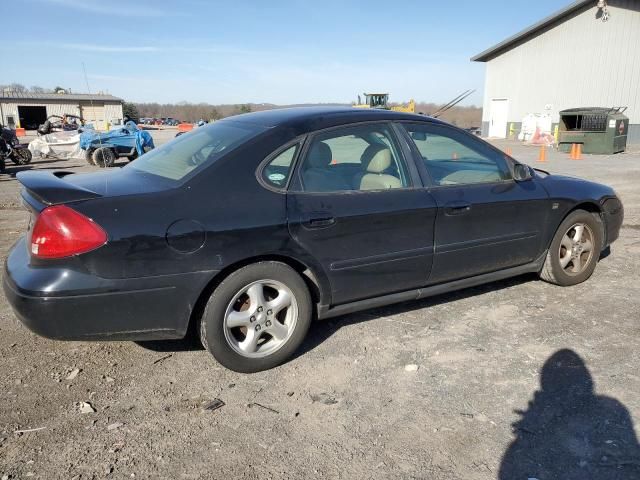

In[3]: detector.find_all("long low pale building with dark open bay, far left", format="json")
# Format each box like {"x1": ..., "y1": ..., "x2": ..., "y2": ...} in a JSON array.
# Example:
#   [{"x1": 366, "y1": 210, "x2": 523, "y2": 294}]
[{"x1": 0, "y1": 92, "x2": 123, "y2": 130}]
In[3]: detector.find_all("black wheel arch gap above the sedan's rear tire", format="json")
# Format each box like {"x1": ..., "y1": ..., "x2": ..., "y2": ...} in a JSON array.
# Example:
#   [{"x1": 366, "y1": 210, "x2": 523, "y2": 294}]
[{"x1": 187, "y1": 255, "x2": 321, "y2": 335}]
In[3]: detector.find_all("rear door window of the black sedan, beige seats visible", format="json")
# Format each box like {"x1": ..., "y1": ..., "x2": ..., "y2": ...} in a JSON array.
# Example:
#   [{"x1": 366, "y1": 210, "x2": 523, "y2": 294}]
[{"x1": 300, "y1": 124, "x2": 411, "y2": 192}]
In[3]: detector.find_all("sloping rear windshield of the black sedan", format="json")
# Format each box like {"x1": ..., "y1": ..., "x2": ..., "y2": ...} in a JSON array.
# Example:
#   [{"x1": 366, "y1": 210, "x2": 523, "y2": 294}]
[{"x1": 125, "y1": 121, "x2": 266, "y2": 180}]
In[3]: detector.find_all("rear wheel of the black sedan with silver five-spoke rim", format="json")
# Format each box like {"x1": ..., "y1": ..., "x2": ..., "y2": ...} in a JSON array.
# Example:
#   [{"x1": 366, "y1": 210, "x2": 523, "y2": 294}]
[{"x1": 200, "y1": 261, "x2": 312, "y2": 373}]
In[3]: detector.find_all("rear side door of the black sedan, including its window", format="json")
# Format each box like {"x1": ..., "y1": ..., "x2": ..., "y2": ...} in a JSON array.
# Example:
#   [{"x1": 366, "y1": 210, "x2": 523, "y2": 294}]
[{"x1": 287, "y1": 123, "x2": 437, "y2": 305}]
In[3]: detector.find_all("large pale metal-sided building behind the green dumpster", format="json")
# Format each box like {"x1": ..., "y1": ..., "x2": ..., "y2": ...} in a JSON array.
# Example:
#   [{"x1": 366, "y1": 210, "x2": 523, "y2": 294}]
[{"x1": 471, "y1": 0, "x2": 640, "y2": 143}]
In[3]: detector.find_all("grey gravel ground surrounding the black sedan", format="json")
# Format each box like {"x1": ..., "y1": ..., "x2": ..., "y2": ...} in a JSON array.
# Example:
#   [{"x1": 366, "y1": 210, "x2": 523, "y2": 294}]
[{"x1": 0, "y1": 132, "x2": 640, "y2": 480}]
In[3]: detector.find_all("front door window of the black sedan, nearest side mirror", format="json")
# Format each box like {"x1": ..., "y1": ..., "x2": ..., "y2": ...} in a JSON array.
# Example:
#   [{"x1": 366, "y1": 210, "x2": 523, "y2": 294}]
[{"x1": 403, "y1": 124, "x2": 512, "y2": 186}]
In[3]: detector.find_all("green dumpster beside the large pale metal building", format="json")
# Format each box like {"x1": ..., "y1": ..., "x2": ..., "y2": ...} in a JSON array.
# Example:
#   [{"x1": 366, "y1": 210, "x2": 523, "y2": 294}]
[{"x1": 558, "y1": 107, "x2": 629, "y2": 155}]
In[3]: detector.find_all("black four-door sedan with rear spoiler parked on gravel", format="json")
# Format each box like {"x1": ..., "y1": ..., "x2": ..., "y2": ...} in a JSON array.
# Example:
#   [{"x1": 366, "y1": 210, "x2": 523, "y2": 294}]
[{"x1": 4, "y1": 108, "x2": 623, "y2": 372}]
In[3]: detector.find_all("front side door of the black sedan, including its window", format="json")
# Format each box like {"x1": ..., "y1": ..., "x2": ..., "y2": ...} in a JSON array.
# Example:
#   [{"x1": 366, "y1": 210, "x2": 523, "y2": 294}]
[{"x1": 403, "y1": 122, "x2": 549, "y2": 283}]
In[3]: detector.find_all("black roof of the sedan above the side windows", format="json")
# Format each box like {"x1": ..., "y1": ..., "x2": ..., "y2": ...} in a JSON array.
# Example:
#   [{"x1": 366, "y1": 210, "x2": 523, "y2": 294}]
[{"x1": 223, "y1": 107, "x2": 441, "y2": 132}]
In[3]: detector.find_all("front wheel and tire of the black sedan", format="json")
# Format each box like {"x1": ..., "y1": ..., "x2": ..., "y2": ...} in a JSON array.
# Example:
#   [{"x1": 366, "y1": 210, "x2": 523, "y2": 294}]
[{"x1": 540, "y1": 210, "x2": 604, "y2": 287}]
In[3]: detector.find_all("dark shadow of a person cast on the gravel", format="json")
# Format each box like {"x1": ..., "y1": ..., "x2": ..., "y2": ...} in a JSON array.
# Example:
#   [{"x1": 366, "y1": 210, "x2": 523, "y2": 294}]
[{"x1": 498, "y1": 349, "x2": 640, "y2": 480}]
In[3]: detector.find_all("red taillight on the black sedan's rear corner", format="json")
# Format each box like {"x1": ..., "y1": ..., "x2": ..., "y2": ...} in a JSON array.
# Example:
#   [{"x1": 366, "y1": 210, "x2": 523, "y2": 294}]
[{"x1": 31, "y1": 205, "x2": 107, "y2": 258}]
